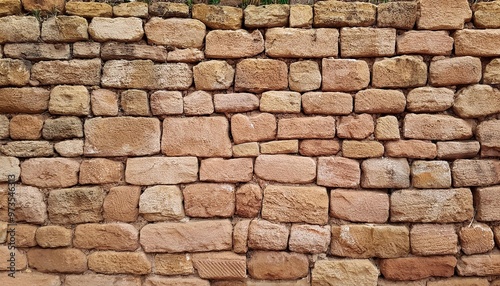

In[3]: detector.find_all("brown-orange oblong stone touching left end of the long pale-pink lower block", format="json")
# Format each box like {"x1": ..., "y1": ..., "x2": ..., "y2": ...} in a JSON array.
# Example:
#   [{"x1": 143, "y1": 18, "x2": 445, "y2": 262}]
[{"x1": 73, "y1": 223, "x2": 139, "y2": 251}]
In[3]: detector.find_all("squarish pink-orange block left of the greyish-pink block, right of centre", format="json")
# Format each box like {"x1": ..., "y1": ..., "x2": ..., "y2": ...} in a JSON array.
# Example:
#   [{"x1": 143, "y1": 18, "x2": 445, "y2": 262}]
[{"x1": 317, "y1": 156, "x2": 361, "y2": 188}]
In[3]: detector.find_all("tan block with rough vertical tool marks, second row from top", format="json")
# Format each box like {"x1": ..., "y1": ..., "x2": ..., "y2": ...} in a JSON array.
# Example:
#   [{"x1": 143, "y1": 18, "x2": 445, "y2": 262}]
[{"x1": 340, "y1": 28, "x2": 396, "y2": 58}]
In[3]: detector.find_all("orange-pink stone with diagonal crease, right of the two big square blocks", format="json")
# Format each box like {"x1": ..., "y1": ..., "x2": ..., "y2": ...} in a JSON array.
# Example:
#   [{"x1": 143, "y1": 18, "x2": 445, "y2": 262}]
[{"x1": 231, "y1": 113, "x2": 277, "y2": 144}]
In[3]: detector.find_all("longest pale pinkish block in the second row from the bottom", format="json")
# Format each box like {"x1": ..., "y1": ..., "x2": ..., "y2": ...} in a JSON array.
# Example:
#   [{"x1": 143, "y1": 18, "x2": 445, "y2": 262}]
[{"x1": 140, "y1": 220, "x2": 233, "y2": 253}]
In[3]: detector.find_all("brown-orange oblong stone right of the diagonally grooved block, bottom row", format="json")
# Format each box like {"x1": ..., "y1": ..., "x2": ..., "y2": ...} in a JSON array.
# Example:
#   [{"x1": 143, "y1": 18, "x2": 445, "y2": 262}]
[{"x1": 248, "y1": 251, "x2": 309, "y2": 280}]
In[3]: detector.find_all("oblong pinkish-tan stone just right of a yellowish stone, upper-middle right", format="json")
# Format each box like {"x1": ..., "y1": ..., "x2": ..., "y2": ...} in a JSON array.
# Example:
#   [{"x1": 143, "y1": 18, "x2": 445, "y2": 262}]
[{"x1": 300, "y1": 91, "x2": 353, "y2": 115}]
